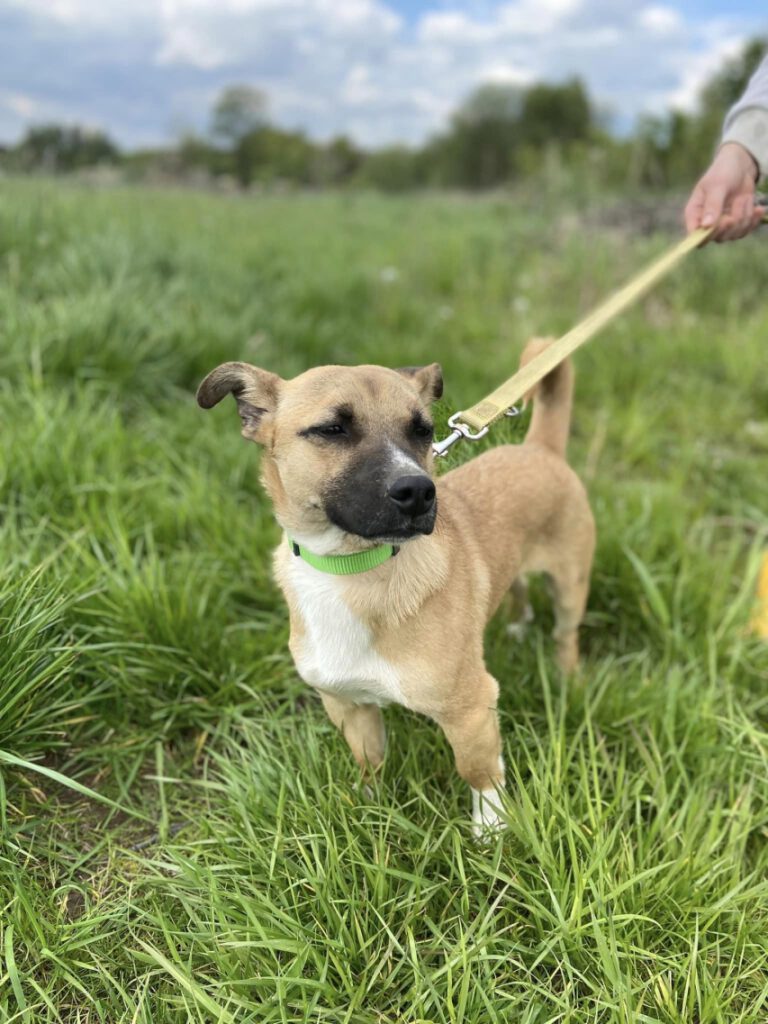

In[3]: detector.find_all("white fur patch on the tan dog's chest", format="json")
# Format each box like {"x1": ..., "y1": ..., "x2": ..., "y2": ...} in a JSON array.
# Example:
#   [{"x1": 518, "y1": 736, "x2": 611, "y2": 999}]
[{"x1": 289, "y1": 558, "x2": 402, "y2": 705}]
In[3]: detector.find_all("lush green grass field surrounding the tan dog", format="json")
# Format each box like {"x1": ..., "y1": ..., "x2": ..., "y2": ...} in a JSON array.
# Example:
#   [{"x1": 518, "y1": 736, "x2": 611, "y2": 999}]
[{"x1": 0, "y1": 181, "x2": 768, "y2": 1024}]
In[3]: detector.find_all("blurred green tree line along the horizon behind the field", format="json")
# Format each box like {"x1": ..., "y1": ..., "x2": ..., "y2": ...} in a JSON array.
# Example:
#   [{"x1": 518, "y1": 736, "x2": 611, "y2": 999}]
[{"x1": 0, "y1": 39, "x2": 768, "y2": 190}]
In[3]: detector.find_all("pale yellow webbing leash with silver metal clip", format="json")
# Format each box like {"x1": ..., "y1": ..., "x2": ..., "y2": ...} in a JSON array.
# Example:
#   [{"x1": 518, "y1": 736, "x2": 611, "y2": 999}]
[{"x1": 432, "y1": 225, "x2": 729, "y2": 456}]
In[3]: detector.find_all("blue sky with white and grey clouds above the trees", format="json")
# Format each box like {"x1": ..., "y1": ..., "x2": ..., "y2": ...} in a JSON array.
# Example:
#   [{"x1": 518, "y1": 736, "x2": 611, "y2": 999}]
[{"x1": 0, "y1": 0, "x2": 768, "y2": 147}]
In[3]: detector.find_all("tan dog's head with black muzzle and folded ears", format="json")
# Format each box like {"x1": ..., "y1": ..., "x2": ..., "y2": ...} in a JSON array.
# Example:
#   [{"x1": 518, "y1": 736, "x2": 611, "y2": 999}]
[{"x1": 198, "y1": 362, "x2": 442, "y2": 553}]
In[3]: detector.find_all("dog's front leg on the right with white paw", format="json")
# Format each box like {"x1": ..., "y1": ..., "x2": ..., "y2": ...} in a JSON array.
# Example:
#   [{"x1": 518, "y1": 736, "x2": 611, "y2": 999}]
[{"x1": 436, "y1": 673, "x2": 504, "y2": 836}]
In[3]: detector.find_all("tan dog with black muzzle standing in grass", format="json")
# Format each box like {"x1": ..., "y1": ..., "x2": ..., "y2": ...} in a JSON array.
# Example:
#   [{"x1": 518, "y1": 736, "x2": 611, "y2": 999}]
[{"x1": 198, "y1": 340, "x2": 595, "y2": 829}]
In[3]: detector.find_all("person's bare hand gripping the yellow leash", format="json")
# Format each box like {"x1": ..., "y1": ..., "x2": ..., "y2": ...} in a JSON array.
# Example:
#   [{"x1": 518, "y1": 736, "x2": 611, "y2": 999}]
[{"x1": 685, "y1": 142, "x2": 766, "y2": 242}]
